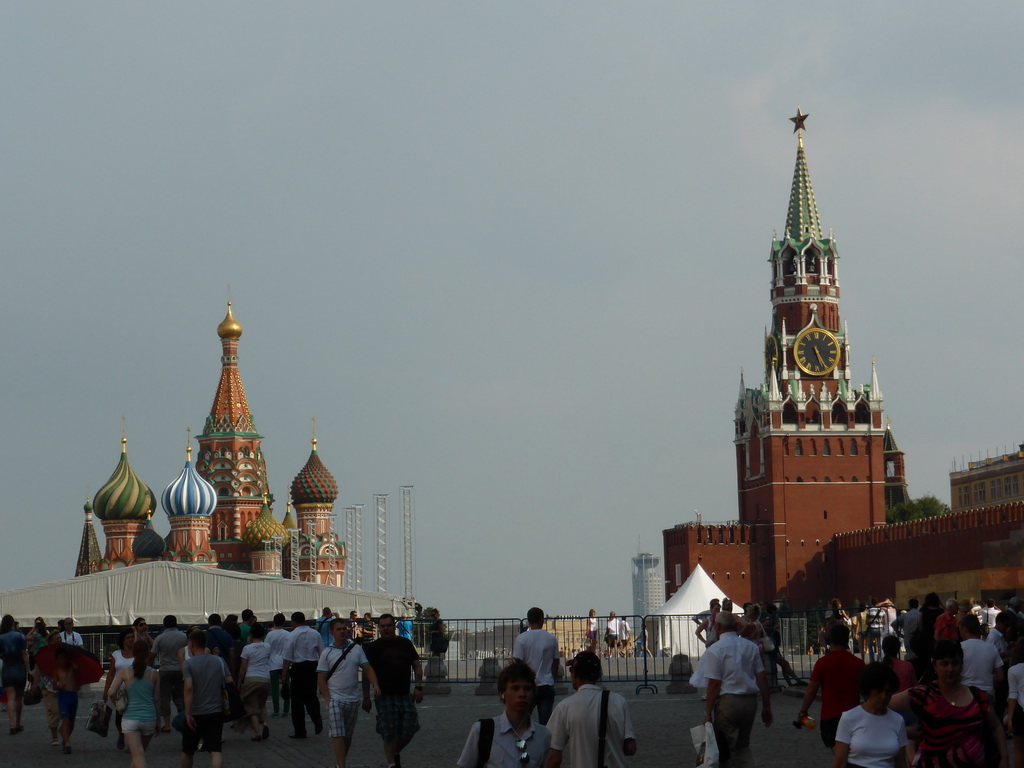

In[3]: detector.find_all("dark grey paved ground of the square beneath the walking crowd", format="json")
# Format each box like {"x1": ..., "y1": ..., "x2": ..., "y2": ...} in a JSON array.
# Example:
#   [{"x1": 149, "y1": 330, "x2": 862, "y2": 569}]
[{"x1": 0, "y1": 683, "x2": 831, "y2": 768}]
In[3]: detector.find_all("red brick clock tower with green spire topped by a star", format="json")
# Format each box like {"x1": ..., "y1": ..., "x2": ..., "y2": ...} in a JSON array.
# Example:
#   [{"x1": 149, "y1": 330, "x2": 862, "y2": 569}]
[{"x1": 734, "y1": 110, "x2": 886, "y2": 607}]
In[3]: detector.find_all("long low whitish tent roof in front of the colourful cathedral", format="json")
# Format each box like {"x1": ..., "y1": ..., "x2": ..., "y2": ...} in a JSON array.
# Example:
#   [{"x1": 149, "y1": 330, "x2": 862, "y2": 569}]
[{"x1": 0, "y1": 562, "x2": 412, "y2": 627}]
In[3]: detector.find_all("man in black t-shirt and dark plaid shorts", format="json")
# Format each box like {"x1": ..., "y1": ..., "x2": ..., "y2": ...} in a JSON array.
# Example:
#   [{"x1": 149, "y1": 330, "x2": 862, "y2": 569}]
[{"x1": 362, "y1": 613, "x2": 423, "y2": 768}]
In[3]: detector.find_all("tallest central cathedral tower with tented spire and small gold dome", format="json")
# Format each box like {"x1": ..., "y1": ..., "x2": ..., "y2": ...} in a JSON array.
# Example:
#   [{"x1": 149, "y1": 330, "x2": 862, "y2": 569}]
[{"x1": 196, "y1": 302, "x2": 272, "y2": 570}]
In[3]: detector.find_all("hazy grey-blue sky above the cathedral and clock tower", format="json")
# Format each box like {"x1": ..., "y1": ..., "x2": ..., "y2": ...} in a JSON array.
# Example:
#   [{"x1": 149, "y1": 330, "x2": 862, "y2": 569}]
[{"x1": 0, "y1": 0, "x2": 1024, "y2": 617}]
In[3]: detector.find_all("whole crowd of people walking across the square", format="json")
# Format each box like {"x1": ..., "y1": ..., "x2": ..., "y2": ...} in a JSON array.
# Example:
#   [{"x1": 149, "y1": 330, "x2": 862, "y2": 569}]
[{"x1": 6, "y1": 593, "x2": 1024, "y2": 768}]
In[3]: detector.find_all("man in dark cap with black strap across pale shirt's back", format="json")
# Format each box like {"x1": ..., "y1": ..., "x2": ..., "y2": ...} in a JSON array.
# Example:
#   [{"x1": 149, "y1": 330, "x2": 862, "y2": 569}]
[{"x1": 548, "y1": 650, "x2": 637, "y2": 768}]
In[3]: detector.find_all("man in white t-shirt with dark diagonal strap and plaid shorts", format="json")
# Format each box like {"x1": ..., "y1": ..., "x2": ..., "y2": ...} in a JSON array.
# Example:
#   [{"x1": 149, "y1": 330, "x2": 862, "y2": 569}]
[{"x1": 316, "y1": 618, "x2": 381, "y2": 768}]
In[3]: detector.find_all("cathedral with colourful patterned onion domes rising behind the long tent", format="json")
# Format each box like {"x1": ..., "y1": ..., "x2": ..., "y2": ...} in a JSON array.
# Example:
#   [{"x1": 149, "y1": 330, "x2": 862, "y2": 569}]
[{"x1": 75, "y1": 302, "x2": 346, "y2": 587}]
